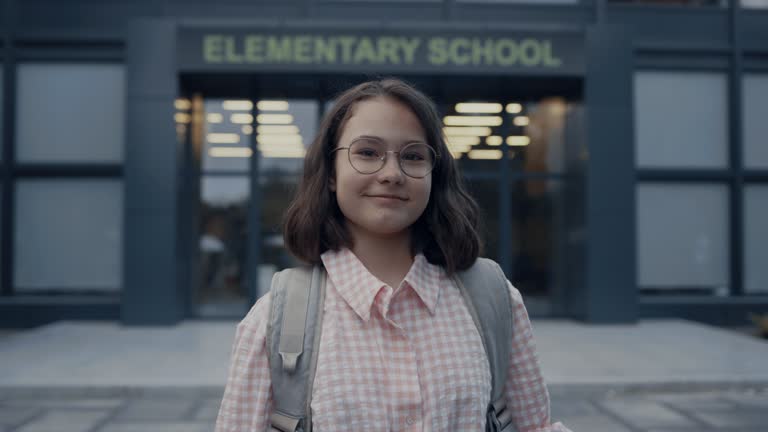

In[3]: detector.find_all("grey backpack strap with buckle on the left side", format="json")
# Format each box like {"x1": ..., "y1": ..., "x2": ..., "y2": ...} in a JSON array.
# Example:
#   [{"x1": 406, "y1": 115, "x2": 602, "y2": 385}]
[{"x1": 267, "y1": 266, "x2": 326, "y2": 432}]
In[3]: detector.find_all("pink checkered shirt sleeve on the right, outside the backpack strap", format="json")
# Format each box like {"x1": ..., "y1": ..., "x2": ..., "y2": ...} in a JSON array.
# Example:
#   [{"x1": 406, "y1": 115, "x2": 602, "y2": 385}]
[{"x1": 505, "y1": 281, "x2": 571, "y2": 432}]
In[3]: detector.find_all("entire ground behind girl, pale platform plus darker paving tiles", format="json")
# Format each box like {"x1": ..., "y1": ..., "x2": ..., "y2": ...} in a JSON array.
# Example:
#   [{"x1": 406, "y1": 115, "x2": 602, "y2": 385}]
[{"x1": 0, "y1": 320, "x2": 768, "y2": 432}]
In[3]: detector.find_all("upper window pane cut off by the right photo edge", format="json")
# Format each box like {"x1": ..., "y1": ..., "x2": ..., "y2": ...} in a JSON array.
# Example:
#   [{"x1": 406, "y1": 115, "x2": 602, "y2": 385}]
[{"x1": 742, "y1": 74, "x2": 768, "y2": 169}]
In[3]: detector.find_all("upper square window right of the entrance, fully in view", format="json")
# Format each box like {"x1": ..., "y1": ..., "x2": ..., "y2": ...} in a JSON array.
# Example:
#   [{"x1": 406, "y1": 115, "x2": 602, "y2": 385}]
[{"x1": 635, "y1": 72, "x2": 728, "y2": 168}]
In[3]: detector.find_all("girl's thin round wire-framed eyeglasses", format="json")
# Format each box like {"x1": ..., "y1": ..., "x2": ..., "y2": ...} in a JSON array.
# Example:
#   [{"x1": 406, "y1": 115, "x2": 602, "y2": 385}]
[{"x1": 331, "y1": 139, "x2": 439, "y2": 178}]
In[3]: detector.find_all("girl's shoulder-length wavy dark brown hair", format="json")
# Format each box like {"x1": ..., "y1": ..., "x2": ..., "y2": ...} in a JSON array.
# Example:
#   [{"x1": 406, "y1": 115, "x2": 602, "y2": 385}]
[{"x1": 283, "y1": 78, "x2": 482, "y2": 274}]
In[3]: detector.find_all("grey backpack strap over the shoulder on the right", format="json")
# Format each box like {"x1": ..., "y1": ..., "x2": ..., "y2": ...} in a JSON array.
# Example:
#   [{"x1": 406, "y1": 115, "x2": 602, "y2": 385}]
[{"x1": 453, "y1": 258, "x2": 515, "y2": 432}]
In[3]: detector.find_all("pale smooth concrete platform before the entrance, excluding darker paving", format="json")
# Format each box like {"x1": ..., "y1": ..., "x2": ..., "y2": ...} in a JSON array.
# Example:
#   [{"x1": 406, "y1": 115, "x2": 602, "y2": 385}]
[{"x1": 0, "y1": 320, "x2": 768, "y2": 394}]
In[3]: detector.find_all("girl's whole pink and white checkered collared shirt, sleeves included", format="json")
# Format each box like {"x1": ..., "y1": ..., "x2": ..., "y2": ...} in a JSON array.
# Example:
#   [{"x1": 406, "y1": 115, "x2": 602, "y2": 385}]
[{"x1": 216, "y1": 249, "x2": 570, "y2": 432}]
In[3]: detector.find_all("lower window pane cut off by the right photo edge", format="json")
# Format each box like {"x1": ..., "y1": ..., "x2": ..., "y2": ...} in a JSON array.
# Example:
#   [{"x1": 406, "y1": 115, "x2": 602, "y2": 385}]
[{"x1": 744, "y1": 185, "x2": 768, "y2": 293}]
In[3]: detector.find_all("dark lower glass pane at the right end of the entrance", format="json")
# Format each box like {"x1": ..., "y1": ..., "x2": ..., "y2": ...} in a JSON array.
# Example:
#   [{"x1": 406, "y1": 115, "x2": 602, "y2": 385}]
[{"x1": 509, "y1": 180, "x2": 565, "y2": 296}]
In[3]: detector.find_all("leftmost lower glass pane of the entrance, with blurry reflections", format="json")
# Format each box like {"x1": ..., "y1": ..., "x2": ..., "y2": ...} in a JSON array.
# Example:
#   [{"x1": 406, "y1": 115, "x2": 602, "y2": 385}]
[{"x1": 197, "y1": 175, "x2": 250, "y2": 316}]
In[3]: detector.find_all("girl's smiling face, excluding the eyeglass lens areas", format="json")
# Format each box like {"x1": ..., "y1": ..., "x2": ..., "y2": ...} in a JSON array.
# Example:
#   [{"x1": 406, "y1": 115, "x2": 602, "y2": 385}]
[{"x1": 330, "y1": 97, "x2": 432, "y2": 238}]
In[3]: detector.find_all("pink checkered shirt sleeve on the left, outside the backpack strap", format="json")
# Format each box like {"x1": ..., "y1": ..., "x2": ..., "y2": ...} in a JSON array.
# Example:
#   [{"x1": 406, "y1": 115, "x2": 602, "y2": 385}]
[{"x1": 215, "y1": 293, "x2": 272, "y2": 432}]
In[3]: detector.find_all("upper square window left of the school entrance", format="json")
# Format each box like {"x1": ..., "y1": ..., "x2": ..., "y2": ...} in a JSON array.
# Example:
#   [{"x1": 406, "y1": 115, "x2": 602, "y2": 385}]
[{"x1": 16, "y1": 63, "x2": 125, "y2": 163}]
